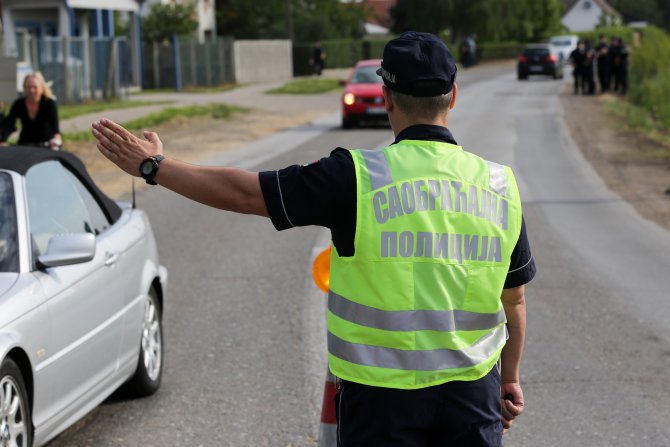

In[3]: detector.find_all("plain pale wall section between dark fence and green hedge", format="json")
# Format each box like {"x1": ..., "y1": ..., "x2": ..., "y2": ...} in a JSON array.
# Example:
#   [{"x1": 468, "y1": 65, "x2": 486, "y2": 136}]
[{"x1": 233, "y1": 40, "x2": 293, "y2": 84}]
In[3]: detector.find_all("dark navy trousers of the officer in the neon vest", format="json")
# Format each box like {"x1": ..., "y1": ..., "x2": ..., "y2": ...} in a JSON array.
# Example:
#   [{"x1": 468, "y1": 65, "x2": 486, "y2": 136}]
[{"x1": 335, "y1": 368, "x2": 502, "y2": 447}]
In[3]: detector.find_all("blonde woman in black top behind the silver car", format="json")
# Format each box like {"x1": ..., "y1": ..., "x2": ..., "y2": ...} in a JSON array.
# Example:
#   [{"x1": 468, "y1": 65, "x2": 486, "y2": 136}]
[{"x1": 0, "y1": 72, "x2": 62, "y2": 150}]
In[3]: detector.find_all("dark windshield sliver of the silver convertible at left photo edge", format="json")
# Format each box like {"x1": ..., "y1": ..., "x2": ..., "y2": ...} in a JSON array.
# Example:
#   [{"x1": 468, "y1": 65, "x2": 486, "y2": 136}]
[{"x1": 0, "y1": 172, "x2": 19, "y2": 272}]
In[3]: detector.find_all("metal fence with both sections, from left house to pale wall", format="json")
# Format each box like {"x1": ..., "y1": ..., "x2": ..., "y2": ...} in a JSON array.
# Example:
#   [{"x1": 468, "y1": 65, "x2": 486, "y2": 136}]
[{"x1": 11, "y1": 34, "x2": 235, "y2": 103}]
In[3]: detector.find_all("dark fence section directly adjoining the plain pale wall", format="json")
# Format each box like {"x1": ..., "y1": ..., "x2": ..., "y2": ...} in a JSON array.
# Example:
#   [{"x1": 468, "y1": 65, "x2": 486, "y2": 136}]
[{"x1": 142, "y1": 38, "x2": 235, "y2": 90}]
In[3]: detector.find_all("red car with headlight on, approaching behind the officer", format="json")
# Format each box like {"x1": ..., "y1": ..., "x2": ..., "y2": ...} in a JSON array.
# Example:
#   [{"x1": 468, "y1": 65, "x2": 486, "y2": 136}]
[{"x1": 342, "y1": 59, "x2": 388, "y2": 129}]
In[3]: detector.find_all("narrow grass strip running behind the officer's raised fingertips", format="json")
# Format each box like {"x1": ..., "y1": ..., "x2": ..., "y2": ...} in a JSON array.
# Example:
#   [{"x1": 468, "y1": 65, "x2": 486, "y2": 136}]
[{"x1": 63, "y1": 104, "x2": 249, "y2": 144}]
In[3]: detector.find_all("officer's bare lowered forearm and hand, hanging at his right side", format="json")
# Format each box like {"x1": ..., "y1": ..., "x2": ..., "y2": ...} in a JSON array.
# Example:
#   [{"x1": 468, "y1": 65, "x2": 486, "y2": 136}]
[{"x1": 500, "y1": 286, "x2": 526, "y2": 431}]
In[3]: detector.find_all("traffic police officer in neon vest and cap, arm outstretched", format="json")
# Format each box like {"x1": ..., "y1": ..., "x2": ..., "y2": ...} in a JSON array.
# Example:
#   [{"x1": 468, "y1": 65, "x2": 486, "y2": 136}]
[{"x1": 93, "y1": 32, "x2": 535, "y2": 447}]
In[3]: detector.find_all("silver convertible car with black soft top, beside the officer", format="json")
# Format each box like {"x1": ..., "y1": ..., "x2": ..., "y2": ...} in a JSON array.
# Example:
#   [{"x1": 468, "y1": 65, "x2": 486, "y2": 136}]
[{"x1": 0, "y1": 147, "x2": 167, "y2": 447}]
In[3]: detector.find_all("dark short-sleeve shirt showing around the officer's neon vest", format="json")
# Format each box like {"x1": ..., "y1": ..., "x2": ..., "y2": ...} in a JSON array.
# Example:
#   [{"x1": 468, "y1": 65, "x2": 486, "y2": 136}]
[{"x1": 259, "y1": 125, "x2": 535, "y2": 288}]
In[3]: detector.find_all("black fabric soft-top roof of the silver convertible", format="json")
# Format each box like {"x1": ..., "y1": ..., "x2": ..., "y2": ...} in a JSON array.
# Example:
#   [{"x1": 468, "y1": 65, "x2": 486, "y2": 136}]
[{"x1": 0, "y1": 146, "x2": 121, "y2": 222}]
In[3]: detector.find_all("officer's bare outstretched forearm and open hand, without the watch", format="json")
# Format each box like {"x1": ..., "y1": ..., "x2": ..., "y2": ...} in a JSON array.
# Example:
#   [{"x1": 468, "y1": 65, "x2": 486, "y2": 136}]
[{"x1": 93, "y1": 119, "x2": 268, "y2": 217}]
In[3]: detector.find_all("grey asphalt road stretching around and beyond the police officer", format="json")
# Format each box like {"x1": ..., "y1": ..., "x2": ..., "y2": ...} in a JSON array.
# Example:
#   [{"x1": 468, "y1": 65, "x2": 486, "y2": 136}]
[{"x1": 50, "y1": 66, "x2": 670, "y2": 447}]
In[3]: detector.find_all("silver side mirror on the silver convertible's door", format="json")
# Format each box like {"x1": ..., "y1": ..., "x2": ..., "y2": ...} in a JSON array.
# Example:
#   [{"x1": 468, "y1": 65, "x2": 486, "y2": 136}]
[{"x1": 37, "y1": 233, "x2": 95, "y2": 267}]
